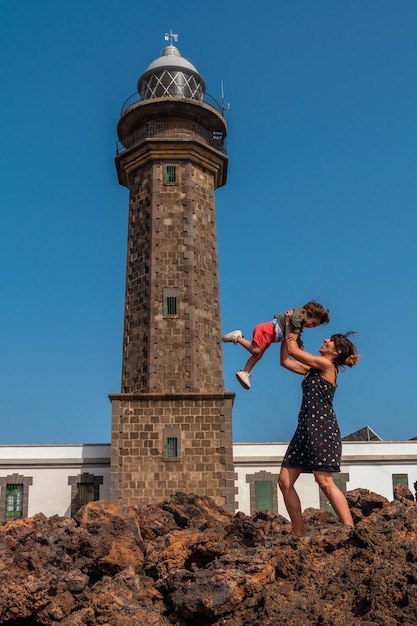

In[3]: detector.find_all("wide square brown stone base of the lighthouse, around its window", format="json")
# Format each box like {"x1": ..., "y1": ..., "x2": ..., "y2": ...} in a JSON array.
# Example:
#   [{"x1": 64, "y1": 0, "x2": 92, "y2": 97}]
[{"x1": 110, "y1": 393, "x2": 235, "y2": 511}]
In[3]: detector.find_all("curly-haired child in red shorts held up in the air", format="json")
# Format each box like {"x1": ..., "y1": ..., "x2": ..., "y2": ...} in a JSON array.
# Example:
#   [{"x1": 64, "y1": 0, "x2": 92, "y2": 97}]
[{"x1": 222, "y1": 300, "x2": 330, "y2": 389}]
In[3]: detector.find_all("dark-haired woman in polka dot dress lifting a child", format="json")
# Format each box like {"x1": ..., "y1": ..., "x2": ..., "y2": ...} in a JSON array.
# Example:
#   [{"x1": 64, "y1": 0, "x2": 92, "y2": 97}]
[{"x1": 279, "y1": 324, "x2": 359, "y2": 537}]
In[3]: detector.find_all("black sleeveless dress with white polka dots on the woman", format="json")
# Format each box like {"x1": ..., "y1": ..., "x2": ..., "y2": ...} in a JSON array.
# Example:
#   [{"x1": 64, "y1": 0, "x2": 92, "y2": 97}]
[{"x1": 282, "y1": 369, "x2": 342, "y2": 472}]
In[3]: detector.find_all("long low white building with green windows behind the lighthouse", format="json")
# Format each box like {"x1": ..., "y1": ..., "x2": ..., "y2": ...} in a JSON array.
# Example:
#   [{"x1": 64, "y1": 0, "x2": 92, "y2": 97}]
[{"x1": 0, "y1": 427, "x2": 417, "y2": 522}]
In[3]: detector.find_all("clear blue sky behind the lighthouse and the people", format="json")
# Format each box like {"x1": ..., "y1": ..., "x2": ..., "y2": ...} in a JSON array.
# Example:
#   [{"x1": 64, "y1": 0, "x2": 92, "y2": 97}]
[{"x1": 0, "y1": 0, "x2": 417, "y2": 443}]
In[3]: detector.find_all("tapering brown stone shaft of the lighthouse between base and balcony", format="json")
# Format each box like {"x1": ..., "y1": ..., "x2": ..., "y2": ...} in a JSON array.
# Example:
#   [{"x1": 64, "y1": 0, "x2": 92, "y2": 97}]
[{"x1": 122, "y1": 160, "x2": 223, "y2": 393}]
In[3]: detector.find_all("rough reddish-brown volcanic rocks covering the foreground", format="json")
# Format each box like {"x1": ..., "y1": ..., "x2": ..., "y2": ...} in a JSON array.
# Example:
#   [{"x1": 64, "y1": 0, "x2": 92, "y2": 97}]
[{"x1": 0, "y1": 488, "x2": 417, "y2": 626}]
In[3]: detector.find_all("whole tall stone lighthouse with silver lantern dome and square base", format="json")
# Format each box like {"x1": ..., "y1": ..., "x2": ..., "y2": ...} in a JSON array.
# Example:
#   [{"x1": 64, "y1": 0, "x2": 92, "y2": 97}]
[{"x1": 110, "y1": 37, "x2": 235, "y2": 510}]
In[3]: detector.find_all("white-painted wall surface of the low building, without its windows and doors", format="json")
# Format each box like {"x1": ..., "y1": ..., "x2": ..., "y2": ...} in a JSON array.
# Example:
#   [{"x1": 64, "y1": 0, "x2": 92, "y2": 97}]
[{"x1": 0, "y1": 440, "x2": 417, "y2": 518}]
